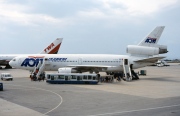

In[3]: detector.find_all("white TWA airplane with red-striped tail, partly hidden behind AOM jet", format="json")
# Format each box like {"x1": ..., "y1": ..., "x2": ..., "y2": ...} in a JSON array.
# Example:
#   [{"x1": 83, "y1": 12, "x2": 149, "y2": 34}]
[{"x1": 0, "y1": 38, "x2": 62, "y2": 68}]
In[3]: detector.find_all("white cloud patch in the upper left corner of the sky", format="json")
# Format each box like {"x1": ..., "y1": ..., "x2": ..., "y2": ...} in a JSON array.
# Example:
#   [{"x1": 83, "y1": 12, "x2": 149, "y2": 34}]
[{"x1": 0, "y1": 1, "x2": 64, "y2": 26}]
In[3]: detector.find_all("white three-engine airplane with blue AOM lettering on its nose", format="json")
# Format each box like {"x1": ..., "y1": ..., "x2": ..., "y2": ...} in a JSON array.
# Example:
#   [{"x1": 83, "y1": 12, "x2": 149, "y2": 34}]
[{"x1": 9, "y1": 26, "x2": 168, "y2": 80}]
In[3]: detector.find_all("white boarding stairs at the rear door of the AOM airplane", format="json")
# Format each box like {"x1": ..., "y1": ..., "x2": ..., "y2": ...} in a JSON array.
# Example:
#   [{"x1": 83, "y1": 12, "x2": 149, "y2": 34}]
[{"x1": 123, "y1": 59, "x2": 132, "y2": 81}]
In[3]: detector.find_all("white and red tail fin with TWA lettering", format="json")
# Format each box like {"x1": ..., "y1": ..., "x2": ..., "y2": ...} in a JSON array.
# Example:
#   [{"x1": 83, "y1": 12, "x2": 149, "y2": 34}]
[{"x1": 40, "y1": 38, "x2": 63, "y2": 54}]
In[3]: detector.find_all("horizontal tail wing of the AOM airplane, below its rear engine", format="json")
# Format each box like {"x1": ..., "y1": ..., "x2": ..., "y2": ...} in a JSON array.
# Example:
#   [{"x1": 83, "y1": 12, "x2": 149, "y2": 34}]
[{"x1": 134, "y1": 56, "x2": 165, "y2": 63}]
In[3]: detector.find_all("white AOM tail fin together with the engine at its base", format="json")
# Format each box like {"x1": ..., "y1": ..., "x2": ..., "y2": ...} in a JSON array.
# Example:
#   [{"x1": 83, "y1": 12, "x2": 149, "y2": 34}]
[{"x1": 127, "y1": 26, "x2": 168, "y2": 56}]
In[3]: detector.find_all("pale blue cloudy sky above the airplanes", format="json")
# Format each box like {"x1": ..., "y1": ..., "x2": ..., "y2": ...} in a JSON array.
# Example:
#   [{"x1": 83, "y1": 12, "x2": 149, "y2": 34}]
[{"x1": 0, "y1": 0, "x2": 180, "y2": 59}]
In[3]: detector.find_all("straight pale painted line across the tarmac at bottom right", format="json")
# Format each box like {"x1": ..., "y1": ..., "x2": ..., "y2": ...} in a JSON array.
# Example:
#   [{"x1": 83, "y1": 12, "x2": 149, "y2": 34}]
[{"x1": 88, "y1": 104, "x2": 180, "y2": 116}]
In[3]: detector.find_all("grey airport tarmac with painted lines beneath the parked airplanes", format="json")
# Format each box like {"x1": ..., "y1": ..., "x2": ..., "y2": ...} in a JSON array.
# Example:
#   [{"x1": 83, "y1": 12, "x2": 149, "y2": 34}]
[{"x1": 0, "y1": 64, "x2": 180, "y2": 116}]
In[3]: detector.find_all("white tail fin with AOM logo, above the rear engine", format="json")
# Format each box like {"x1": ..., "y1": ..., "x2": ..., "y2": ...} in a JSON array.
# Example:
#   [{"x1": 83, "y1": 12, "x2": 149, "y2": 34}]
[{"x1": 138, "y1": 26, "x2": 165, "y2": 47}]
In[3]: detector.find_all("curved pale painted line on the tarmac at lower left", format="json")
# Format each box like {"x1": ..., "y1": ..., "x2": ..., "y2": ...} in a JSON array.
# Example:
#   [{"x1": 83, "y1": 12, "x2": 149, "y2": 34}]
[{"x1": 7, "y1": 84, "x2": 63, "y2": 115}]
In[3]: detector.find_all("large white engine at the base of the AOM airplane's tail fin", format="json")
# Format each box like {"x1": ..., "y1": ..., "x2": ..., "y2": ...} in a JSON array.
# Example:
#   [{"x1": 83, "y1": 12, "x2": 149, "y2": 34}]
[{"x1": 127, "y1": 45, "x2": 168, "y2": 56}]
